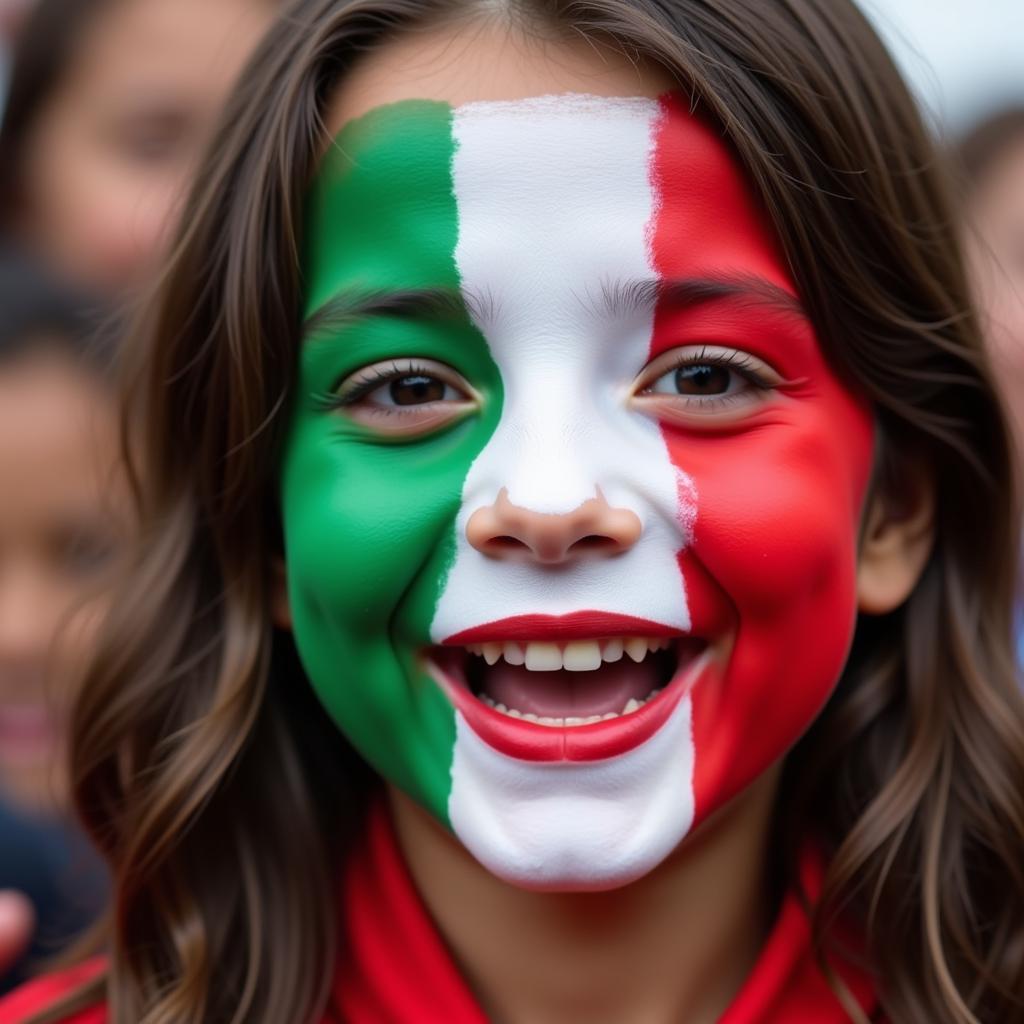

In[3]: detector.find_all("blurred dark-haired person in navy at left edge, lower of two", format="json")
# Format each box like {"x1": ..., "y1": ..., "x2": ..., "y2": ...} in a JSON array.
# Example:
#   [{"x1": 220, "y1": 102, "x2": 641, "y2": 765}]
[{"x1": 0, "y1": 253, "x2": 119, "y2": 991}]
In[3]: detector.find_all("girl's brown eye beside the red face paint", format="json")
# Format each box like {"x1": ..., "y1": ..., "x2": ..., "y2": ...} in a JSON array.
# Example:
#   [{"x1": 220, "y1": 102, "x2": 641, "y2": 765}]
[{"x1": 634, "y1": 345, "x2": 784, "y2": 419}]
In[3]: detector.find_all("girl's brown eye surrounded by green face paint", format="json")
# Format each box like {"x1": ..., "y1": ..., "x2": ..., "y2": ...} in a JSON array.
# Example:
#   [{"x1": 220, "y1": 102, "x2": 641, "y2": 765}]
[{"x1": 324, "y1": 358, "x2": 479, "y2": 436}]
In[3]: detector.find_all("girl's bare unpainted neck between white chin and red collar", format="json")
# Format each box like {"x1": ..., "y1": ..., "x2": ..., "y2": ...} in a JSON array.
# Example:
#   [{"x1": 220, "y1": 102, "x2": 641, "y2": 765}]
[{"x1": 390, "y1": 770, "x2": 778, "y2": 1024}]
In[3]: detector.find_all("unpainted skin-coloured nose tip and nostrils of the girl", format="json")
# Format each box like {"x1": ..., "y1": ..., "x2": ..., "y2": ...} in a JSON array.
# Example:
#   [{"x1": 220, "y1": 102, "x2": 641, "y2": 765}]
[{"x1": 466, "y1": 487, "x2": 643, "y2": 565}]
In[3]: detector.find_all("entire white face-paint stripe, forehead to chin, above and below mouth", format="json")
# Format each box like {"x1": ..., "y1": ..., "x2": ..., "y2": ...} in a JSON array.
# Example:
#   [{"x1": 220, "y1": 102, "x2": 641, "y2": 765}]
[{"x1": 431, "y1": 96, "x2": 696, "y2": 889}]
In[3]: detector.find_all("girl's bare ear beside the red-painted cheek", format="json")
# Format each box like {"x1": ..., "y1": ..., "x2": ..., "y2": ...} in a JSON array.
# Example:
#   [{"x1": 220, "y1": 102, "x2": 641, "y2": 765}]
[{"x1": 857, "y1": 477, "x2": 935, "y2": 615}]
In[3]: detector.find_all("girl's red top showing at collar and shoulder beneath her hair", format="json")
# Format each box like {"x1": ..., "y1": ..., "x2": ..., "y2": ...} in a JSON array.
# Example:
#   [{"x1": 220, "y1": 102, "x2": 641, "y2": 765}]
[{"x1": 0, "y1": 806, "x2": 877, "y2": 1024}]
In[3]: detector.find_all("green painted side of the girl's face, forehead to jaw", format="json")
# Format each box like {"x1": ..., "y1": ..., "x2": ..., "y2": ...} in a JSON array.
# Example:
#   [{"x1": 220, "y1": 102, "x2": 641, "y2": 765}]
[{"x1": 281, "y1": 101, "x2": 502, "y2": 822}]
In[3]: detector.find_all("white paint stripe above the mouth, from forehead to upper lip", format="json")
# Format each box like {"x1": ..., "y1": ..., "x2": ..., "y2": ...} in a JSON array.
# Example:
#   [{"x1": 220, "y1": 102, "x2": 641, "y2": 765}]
[{"x1": 431, "y1": 96, "x2": 695, "y2": 641}]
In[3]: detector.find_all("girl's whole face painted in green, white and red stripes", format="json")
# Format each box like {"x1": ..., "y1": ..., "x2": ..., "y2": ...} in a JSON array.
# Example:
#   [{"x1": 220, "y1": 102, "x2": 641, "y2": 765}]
[{"x1": 282, "y1": 22, "x2": 872, "y2": 889}]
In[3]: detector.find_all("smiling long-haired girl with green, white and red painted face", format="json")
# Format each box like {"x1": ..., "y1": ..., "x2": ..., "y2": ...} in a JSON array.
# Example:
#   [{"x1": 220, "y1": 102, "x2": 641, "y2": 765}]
[{"x1": 0, "y1": 0, "x2": 1024, "y2": 1024}]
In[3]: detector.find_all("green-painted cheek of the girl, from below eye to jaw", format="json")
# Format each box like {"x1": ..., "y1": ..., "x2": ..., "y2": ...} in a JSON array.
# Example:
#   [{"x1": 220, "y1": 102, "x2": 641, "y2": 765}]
[{"x1": 282, "y1": 424, "x2": 479, "y2": 820}]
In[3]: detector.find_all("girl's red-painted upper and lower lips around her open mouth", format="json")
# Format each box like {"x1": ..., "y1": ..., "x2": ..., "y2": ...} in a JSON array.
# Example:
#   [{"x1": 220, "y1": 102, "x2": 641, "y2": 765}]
[{"x1": 425, "y1": 611, "x2": 711, "y2": 763}]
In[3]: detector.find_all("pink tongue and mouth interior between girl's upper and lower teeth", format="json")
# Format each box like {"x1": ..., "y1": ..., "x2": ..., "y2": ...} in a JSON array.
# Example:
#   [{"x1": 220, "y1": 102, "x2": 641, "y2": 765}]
[{"x1": 481, "y1": 657, "x2": 658, "y2": 718}]
